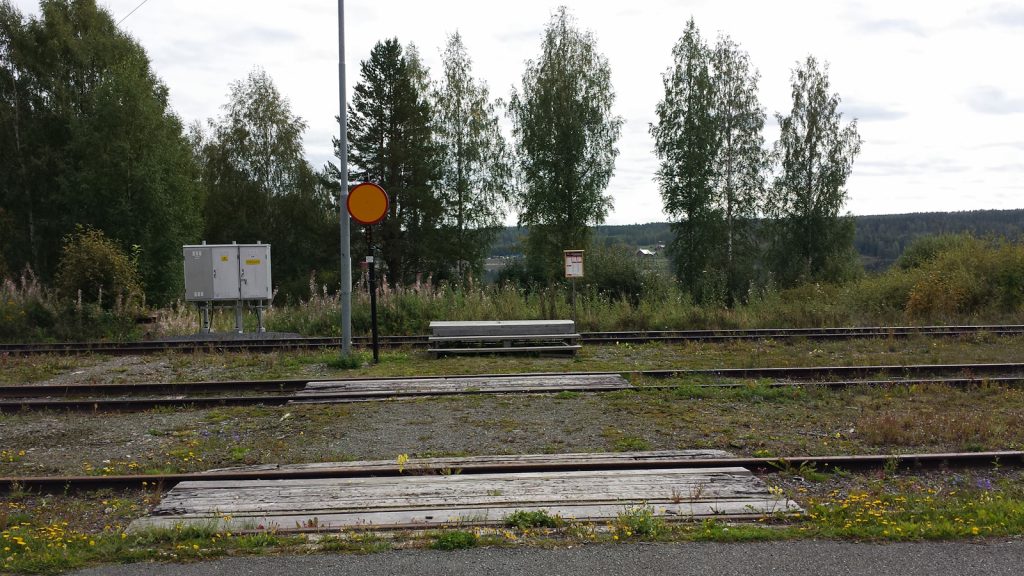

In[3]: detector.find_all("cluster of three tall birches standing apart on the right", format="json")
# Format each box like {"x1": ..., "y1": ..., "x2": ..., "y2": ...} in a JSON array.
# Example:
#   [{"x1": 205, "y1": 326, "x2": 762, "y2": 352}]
[{"x1": 650, "y1": 18, "x2": 861, "y2": 304}]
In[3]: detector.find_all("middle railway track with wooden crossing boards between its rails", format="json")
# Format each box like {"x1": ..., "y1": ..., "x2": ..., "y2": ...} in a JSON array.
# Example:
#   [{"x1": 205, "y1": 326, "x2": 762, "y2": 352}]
[{"x1": 0, "y1": 364, "x2": 1024, "y2": 413}]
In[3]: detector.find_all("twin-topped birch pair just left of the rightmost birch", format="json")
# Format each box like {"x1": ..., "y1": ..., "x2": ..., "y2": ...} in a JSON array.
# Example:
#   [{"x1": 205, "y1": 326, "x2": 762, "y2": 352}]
[{"x1": 650, "y1": 18, "x2": 766, "y2": 303}]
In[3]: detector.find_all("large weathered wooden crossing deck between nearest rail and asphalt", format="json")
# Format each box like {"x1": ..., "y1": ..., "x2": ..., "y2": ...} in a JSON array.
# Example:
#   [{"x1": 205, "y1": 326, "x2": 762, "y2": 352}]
[{"x1": 130, "y1": 455, "x2": 799, "y2": 530}]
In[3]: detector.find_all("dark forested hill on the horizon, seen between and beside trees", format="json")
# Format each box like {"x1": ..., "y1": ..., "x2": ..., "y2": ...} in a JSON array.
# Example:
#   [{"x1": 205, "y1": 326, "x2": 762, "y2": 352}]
[{"x1": 490, "y1": 209, "x2": 1024, "y2": 271}]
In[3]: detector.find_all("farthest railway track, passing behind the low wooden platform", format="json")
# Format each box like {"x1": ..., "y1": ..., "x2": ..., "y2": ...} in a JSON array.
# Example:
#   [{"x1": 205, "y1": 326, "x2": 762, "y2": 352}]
[{"x1": 0, "y1": 325, "x2": 1024, "y2": 356}]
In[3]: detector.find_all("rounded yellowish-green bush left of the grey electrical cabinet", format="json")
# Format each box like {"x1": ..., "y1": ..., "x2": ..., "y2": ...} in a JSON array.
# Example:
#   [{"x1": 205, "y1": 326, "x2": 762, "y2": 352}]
[{"x1": 56, "y1": 227, "x2": 144, "y2": 311}]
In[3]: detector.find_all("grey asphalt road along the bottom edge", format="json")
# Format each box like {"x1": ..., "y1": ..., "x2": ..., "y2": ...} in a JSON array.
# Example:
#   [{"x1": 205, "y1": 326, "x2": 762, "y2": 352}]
[{"x1": 75, "y1": 539, "x2": 1024, "y2": 576}]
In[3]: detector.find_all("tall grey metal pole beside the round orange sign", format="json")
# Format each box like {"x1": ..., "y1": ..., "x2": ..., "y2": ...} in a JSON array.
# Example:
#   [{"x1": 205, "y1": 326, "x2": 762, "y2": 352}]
[{"x1": 338, "y1": 0, "x2": 352, "y2": 358}]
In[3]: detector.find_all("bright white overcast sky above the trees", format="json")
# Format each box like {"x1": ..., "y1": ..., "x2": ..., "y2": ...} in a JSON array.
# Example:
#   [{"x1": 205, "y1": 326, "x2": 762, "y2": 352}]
[{"x1": 14, "y1": 0, "x2": 1024, "y2": 224}]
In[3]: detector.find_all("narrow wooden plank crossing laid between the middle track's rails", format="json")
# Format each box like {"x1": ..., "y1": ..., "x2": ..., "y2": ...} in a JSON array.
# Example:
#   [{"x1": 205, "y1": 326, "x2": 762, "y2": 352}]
[{"x1": 286, "y1": 374, "x2": 633, "y2": 403}]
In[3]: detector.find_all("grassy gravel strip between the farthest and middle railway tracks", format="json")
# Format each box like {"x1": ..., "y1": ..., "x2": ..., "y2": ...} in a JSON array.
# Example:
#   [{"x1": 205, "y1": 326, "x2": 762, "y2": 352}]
[{"x1": 8, "y1": 335, "x2": 1024, "y2": 383}]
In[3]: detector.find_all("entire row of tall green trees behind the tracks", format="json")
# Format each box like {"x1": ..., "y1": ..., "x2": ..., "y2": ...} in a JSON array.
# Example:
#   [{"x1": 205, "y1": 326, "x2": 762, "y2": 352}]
[{"x1": 0, "y1": 0, "x2": 860, "y2": 304}]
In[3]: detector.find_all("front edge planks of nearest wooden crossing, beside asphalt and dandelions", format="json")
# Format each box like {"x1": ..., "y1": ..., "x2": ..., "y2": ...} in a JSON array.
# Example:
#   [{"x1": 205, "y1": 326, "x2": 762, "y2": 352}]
[{"x1": 128, "y1": 498, "x2": 801, "y2": 531}]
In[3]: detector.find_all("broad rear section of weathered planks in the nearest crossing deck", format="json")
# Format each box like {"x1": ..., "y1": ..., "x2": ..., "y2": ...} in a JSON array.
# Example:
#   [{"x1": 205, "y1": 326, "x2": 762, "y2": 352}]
[{"x1": 153, "y1": 468, "x2": 768, "y2": 516}]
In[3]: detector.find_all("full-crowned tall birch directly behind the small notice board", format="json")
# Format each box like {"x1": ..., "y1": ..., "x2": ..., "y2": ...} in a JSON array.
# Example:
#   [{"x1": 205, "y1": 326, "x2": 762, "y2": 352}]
[{"x1": 509, "y1": 7, "x2": 623, "y2": 278}]
